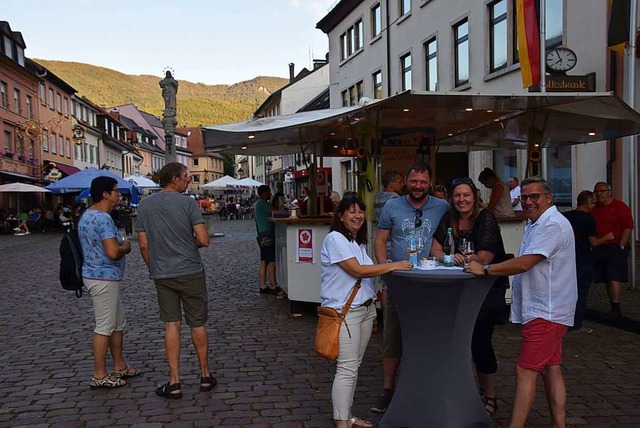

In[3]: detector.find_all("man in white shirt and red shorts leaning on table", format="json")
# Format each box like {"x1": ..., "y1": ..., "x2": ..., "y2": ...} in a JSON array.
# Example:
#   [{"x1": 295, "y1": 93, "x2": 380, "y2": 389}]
[{"x1": 465, "y1": 177, "x2": 578, "y2": 427}]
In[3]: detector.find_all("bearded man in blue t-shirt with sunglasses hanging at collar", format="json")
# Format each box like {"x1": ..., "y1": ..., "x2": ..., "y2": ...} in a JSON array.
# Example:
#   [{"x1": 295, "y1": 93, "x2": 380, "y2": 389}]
[{"x1": 371, "y1": 162, "x2": 449, "y2": 413}]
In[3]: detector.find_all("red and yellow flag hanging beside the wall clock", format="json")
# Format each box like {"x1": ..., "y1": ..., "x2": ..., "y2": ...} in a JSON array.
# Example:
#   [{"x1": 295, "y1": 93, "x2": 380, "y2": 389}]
[{"x1": 516, "y1": 0, "x2": 540, "y2": 88}]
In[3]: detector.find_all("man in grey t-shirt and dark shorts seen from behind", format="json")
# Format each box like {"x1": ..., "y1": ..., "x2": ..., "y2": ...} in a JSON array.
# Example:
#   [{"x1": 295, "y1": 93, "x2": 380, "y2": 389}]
[{"x1": 136, "y1": 162, "x2": 217, "y2": 398}]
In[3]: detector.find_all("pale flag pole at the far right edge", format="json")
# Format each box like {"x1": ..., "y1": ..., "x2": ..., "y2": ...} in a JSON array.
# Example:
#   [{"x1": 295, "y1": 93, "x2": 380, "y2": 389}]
[{"x1": 627, "y1": 0, "x2": 638, "y2": 290}]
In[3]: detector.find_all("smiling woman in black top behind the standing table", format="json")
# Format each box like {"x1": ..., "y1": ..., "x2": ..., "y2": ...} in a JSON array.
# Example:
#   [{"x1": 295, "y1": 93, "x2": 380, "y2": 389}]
[{"x1": 431, "y1": 177, "x2": 509, "y2": 415}]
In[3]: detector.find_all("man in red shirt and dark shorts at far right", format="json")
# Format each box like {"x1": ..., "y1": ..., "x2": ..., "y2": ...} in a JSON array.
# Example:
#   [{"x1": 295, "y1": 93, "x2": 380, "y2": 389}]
[{"x1": 591, "y1": 182, "x2": 633, "y2": 321}]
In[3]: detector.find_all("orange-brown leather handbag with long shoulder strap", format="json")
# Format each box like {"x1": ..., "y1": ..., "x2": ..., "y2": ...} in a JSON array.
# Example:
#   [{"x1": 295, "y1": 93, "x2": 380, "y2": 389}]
[{"x1": 316, "y1": 279, "x2": 361, "y2": 360}]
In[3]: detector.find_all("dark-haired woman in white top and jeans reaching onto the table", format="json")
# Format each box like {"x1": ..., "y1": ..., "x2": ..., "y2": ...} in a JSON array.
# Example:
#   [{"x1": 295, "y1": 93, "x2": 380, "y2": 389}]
[{"x1": 320, "y1": 193, "x2": 412, "y2": 428}]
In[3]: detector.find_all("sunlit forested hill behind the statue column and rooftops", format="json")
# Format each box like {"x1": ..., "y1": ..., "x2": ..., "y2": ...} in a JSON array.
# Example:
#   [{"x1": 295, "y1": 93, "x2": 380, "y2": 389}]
[{"x1": 34, "y1": 59, "x2": 288, "y2": 127}]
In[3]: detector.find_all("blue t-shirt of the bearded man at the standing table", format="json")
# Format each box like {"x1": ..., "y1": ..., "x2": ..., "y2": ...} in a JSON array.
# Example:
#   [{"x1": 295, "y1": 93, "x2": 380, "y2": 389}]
[{"x1": 378, "y1": 196, "x2": 449, "y2": 262}]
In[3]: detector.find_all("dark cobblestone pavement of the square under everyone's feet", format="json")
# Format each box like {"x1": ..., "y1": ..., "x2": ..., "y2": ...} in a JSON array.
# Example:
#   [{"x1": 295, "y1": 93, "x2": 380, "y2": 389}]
[{"x1": 0, "y1": 220, "x2": 640, "y2": 428}]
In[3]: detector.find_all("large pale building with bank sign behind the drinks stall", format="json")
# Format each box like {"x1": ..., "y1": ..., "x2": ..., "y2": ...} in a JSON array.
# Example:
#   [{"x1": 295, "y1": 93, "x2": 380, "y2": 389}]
[{"x1": 317, "y1": 0, "x2": 636, "y2": 205}]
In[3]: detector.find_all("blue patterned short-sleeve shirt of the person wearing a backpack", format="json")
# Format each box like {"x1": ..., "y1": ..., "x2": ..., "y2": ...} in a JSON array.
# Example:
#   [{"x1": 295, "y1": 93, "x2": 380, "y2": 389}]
[{"x1": 78, "y1": 209, "x2": 124, "y2": 281}]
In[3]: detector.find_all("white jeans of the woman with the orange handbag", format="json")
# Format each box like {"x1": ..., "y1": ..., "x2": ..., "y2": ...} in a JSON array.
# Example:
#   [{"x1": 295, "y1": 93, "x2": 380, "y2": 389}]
[{"x1": 331, "y1": 304, "x2": 376, "y2": 421}]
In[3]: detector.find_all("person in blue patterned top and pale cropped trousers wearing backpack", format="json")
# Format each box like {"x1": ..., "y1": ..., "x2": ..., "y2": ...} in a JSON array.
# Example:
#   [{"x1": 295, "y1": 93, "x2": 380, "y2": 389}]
[{"x1": 78, "y1": 176, "x2": 142, "y2": 389}]
